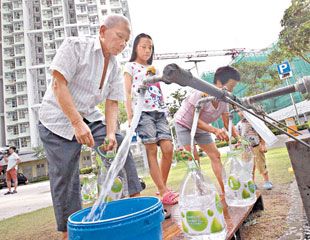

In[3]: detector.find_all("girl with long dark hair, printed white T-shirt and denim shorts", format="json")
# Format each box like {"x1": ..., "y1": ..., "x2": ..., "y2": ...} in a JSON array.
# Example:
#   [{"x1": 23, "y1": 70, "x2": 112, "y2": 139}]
[{"x1": 124, "y1": 33, "x2": 178, "y2": 205}]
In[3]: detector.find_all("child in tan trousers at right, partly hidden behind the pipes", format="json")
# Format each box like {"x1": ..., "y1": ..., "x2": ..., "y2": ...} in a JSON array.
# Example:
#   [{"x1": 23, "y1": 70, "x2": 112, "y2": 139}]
[{"x1": 236, "y1": 112, "x2": 272, "y2": 190}]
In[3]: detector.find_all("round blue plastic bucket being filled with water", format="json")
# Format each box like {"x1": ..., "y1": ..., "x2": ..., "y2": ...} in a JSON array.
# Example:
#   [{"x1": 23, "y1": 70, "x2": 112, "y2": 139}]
[{"x1": 68, "y1": 197, "x2": 165, "y2": 240}]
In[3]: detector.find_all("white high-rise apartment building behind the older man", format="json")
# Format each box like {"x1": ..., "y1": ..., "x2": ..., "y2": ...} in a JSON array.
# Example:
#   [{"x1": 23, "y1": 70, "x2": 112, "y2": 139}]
[{"x1": 0, "y1": 0, "x2": 130, "y2": 152}]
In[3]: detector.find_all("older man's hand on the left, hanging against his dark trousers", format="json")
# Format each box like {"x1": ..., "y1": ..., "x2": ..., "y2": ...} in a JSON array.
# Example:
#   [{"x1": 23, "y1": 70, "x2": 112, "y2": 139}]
[{"x1": 72, "y1": 120, "x2": 95, "y2": 147}]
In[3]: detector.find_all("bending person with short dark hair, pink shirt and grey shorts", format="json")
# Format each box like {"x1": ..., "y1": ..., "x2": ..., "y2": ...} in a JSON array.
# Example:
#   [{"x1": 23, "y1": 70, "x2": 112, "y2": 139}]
[{"x1": 174, "y1": 66, "x2": 240, "y2": 193}]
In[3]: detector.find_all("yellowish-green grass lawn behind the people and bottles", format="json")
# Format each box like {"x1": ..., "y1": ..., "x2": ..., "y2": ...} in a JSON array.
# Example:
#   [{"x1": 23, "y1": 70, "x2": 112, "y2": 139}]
[{"x1": 0, "y1": 148, "x2": 294, "y2": 240}]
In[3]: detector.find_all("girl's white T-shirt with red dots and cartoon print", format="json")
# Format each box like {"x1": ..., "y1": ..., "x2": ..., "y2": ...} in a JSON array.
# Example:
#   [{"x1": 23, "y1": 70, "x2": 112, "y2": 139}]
[{"x1": 124, "y1": 62, "x2": 167, "y2": 112}]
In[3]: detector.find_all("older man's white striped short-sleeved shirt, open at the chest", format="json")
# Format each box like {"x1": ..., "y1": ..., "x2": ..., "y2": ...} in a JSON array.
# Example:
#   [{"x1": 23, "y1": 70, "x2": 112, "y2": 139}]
[{"x1": 39, "y1": 36, "x2": 126, "y2": 140}]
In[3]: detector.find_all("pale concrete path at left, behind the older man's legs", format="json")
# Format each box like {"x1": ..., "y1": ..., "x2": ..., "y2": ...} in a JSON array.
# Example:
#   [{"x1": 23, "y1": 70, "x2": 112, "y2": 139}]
[{"x1": 0, "y1": 181, "x2": 52, "y2": 221}]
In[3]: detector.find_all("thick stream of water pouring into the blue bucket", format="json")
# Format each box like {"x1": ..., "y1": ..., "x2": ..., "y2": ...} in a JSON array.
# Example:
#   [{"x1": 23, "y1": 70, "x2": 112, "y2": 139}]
[{"x1": 82, "y1": 90, "x2": 145, "y2": 222}]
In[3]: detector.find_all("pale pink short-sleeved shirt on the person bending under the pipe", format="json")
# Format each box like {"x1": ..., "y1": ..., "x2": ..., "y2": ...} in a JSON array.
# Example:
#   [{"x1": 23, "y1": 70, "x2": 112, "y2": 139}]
[{"x1": 174, "y1": 90, "x2": 229, "y2": 133}]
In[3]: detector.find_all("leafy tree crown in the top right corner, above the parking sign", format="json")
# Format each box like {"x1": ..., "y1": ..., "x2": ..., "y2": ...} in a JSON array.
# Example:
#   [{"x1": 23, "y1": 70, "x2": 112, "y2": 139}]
[{"x1": 269, "y1": 0, "x2": 310, "y2": 64}]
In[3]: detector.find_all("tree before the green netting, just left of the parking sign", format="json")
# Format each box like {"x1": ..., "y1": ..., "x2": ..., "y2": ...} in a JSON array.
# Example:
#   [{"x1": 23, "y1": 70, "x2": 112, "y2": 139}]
[{"x1": 232, "y1": 61, "x2": 283, "y2": 96}]
